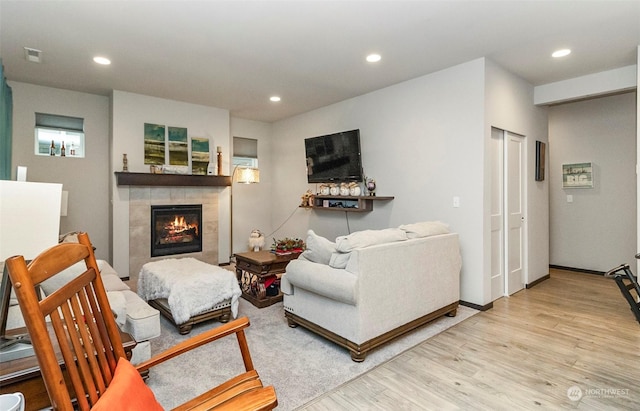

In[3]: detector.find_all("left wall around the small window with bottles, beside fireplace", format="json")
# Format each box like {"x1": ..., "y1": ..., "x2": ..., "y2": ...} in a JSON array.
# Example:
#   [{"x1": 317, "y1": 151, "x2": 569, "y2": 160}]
[{"x1": 9, "y1": 82, "x2": 111, "y2": 261}]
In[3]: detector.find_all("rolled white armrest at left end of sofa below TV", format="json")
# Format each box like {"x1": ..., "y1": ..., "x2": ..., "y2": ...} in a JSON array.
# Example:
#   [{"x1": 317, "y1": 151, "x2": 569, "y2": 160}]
[{"x1": 283, "y1": 260, "x2": 358, "y2": 305}]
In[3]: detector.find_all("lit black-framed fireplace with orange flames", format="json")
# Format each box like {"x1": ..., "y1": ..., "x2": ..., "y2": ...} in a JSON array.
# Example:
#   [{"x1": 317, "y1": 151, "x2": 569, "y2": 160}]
[{"x1": 151, "y1": 204, "x2": 202, "y2": 257}]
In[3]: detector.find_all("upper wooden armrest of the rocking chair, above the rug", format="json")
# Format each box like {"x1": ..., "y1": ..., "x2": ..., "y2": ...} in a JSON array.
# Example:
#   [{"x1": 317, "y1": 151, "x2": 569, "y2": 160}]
[{"x1": 136, "y1": 317, "x2": 249, "y2": 372}]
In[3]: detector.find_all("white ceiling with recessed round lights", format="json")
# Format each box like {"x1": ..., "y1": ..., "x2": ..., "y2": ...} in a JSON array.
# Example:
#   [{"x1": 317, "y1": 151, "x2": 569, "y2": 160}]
[{"x1": 0, "y1": 0, "x2": 640, "y2": 122}]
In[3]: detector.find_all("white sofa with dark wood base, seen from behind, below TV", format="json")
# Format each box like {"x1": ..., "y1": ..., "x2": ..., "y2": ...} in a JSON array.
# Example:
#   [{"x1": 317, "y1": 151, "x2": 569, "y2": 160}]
[{"x1": 281, "y1": 222, "x2": 462, "y2": 362}]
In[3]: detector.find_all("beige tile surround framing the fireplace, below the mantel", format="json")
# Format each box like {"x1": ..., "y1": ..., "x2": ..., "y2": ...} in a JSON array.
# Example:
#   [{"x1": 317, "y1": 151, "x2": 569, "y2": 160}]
[{"x1": 129, "y1": 186, "x2": 221, "y2": 284}]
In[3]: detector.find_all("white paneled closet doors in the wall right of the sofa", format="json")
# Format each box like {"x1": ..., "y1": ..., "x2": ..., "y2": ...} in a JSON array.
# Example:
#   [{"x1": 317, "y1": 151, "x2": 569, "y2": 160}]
[{"x1": 491, "y1": 128, "x2": 526, "y2": 301}]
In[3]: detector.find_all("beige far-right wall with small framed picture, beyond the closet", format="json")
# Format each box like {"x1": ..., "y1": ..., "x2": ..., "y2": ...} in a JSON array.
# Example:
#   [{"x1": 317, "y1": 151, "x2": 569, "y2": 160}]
[{"x1": 548, "y1": 92, "x2": 637, "y2": 271}]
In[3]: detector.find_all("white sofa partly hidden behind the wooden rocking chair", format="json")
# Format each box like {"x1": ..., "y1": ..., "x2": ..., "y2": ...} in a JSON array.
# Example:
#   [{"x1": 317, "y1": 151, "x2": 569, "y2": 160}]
[{"x1": 7, "y1": 260, "x2": 160, "y2": 364}]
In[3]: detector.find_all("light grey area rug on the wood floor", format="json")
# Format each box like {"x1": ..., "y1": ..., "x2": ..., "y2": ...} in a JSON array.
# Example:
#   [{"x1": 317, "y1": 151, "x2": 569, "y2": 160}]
[{"x1": 147, "y1": 299, "x2": 478, "y2": 411}]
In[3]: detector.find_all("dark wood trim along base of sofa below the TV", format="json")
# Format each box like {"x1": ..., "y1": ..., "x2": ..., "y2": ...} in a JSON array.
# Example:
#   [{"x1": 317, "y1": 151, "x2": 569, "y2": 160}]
[{"x1": 284, "y1": 301, "x2": 458, "y2": 362}]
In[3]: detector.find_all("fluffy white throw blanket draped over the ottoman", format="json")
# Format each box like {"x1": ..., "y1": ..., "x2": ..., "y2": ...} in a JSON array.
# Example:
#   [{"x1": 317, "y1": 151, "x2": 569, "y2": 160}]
[{"x1": 138, "y1": 258, "x2": 241, "y2": 324}]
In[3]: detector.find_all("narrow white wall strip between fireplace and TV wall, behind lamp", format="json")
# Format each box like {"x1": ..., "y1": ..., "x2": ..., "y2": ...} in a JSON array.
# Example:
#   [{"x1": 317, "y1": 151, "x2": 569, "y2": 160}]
[{"x1": 231, "y1": 117, "x2": 274, "y2": 253}]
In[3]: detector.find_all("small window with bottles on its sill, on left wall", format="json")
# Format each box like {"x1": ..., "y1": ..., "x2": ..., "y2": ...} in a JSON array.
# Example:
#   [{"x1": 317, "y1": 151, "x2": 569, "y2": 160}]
[{"x1": 35, "y1": 113, "x2": 84, "y2": 158}]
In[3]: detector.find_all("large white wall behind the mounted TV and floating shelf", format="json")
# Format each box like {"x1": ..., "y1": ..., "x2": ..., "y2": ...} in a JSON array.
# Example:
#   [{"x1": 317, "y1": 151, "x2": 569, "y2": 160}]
[{"x1": 272, "y1": 59, "x2": 496, "y2": 304}]
